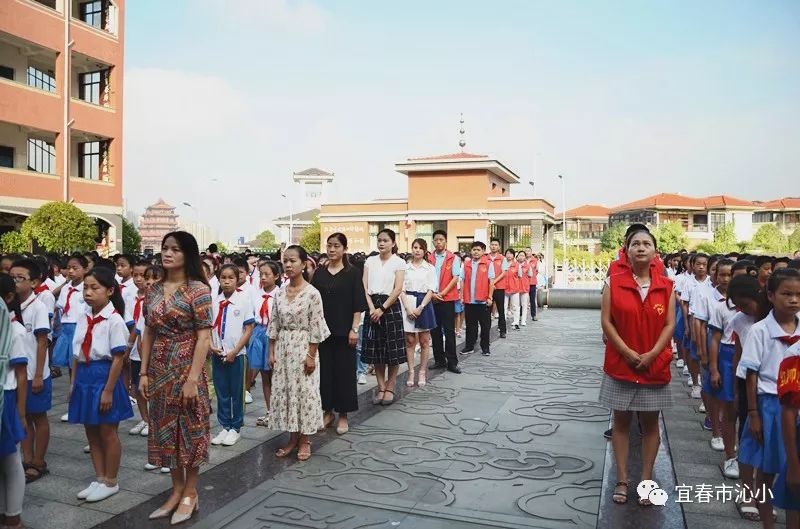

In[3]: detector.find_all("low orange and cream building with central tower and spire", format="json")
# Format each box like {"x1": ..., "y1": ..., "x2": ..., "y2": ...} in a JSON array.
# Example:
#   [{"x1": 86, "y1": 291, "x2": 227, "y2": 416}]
[{"x1": 319, "y1": 152, "x2": 556, "y2": 255}]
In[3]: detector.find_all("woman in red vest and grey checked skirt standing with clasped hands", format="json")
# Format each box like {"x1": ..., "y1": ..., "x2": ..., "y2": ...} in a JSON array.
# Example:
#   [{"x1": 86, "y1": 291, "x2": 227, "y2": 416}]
[{"x1": 599, "y1": 228, "x2": 675, "y2": 506}]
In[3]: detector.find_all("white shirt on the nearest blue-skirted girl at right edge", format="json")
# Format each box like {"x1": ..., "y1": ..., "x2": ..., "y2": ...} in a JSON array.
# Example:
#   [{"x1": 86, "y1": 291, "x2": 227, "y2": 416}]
[{"x1": 739, "y1": 311, "x2": 800, "y2": 395}]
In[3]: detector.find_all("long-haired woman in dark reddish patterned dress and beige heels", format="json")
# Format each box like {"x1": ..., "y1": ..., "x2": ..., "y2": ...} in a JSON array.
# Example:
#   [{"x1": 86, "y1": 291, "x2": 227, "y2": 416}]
[{"x1": 139, "y1": 231, "x2": 212, "y2": 525}]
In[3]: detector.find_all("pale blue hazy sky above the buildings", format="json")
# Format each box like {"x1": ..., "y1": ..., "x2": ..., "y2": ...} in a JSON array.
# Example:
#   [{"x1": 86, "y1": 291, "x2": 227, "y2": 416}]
[{"x1": 124, "y1": 0, "x2": 800, "y2": 241}]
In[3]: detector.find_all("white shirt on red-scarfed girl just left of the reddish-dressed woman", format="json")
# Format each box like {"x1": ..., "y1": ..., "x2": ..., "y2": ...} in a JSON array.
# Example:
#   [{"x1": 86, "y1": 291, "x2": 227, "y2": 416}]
[{"x1": 72, "y1": 302, "x2": 130, "y2": 363}]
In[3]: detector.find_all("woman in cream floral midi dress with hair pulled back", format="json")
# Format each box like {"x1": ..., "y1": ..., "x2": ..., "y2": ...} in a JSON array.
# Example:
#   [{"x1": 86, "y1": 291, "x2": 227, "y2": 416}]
[{"x1": 267, "y1": 245, "x2": 330, "y2": 461}]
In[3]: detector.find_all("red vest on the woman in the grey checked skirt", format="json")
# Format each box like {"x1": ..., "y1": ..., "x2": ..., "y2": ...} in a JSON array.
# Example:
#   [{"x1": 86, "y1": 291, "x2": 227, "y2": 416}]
[{"x1": 603, "y1": 268, "x2": 672, "y2": 384}]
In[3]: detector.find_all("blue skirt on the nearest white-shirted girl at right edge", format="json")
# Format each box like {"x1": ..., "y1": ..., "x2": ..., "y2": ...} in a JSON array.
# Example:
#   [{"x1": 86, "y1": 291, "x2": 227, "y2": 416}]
[{"x1": 739, "y1": 393, "x2": 786, "y2": 474}]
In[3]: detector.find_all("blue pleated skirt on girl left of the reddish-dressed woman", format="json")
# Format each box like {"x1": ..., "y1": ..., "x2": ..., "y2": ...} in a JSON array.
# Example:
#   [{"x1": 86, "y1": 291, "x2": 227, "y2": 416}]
[{"x1": 69, "y1": 360, "x2": 133, "y2": 425}]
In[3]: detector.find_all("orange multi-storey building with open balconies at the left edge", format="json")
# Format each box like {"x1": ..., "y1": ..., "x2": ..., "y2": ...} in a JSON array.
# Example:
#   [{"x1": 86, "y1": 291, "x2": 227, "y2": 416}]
[{"x1": 0, "y1": 0, "x2": 125, "y2": 253}]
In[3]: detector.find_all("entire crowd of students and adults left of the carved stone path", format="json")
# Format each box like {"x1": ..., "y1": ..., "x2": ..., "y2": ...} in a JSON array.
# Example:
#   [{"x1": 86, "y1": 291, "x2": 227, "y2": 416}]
[{"x1": 0, "y1": 229, "x2": 546, "y2": 527}]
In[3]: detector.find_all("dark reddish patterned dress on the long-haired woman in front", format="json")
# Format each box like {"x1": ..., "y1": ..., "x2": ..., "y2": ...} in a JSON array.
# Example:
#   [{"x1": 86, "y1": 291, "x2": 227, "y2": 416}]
[{"x1": 145, "y1": 281, "x2": 213, "y2": 468}]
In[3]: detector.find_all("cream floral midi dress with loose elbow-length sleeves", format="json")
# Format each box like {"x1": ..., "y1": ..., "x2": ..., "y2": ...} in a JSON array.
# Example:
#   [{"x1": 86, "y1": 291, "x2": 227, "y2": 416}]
[{"x1": 269, "y1": 285, "x2": 331, "y2": 435}]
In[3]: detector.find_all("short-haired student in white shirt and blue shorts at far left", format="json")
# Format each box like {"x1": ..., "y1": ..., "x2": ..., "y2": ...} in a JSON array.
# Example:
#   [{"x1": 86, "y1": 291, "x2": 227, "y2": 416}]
[{"x1": 11, "y1": 259, "x2": 53, "y2": 483}]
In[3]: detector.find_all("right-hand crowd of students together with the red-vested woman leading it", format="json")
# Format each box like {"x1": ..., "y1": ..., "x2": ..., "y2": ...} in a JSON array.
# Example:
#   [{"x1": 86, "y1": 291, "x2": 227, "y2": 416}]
[{"x1": 600, "y1": 225, "x2": 800, "y2": 529}]
